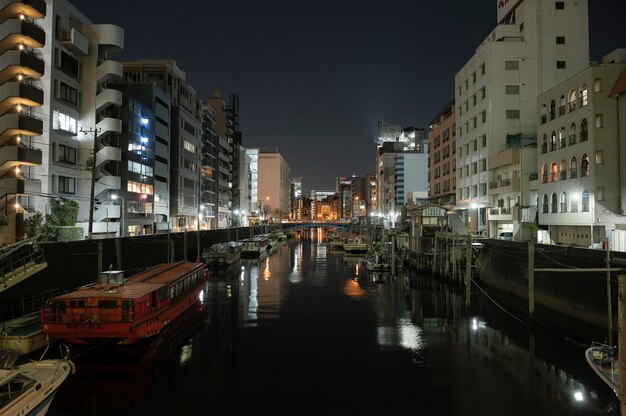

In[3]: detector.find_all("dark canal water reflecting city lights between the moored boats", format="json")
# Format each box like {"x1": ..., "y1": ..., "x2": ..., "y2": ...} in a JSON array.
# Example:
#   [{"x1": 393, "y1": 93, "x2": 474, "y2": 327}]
[{"x1": 49, "y1": 229, "x2": 619, "y2": 416}]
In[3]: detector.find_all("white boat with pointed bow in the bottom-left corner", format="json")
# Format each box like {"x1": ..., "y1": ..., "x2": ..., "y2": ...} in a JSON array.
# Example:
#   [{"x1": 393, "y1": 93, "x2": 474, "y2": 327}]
[{"x1": 0, "y1": 345, "x2": 74, "y2": 416}]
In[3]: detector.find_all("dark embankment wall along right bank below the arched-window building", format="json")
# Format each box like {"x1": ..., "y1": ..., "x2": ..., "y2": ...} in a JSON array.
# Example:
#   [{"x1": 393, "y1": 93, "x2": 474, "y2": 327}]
[{"x1": 476, "y1": 240, "x2": 626, "y2": 330}]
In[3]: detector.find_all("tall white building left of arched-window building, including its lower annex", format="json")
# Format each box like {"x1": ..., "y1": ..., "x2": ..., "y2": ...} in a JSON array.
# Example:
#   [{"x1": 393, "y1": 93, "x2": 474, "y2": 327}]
[{"x1": 455, "y1": 0, "x2": 589, "y2": 240}]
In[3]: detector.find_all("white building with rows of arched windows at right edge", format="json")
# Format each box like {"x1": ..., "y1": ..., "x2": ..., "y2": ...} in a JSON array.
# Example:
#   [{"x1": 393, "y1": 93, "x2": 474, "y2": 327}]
[{"x1": 536, "y1": 49, "x2": 626, "y2": 247}]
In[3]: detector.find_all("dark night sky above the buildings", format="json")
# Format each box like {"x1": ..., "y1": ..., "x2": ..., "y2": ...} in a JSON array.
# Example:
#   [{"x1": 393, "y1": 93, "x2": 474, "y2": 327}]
[{"x1": 72, "y1": 0, "x2": 626, "y2": 192}]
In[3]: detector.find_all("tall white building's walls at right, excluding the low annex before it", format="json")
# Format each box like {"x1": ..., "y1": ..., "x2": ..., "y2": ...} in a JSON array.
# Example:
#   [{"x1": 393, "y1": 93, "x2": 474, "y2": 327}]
[{"x1": 455, "y1": 0, "x2": 589, "y2": 234}]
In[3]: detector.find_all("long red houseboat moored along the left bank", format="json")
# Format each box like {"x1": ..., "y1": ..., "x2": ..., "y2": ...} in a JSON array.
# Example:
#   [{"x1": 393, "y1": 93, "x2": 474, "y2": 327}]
[{"x1": 41, "y1": 261, "x2": 207, "y2": 344}]
